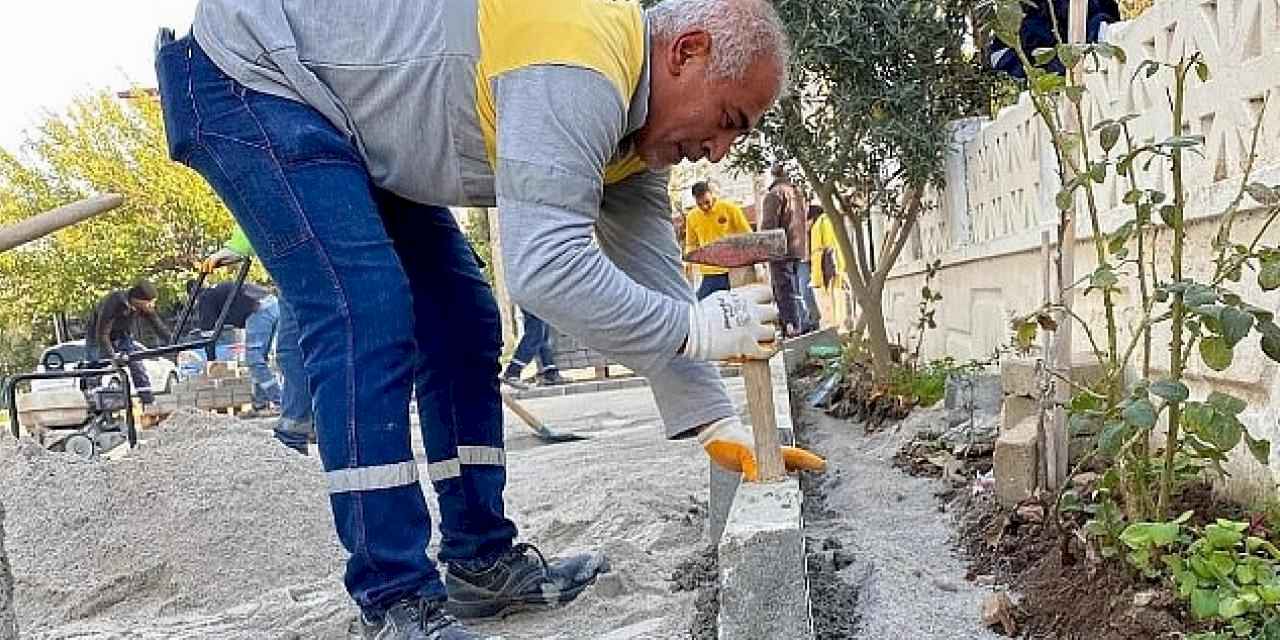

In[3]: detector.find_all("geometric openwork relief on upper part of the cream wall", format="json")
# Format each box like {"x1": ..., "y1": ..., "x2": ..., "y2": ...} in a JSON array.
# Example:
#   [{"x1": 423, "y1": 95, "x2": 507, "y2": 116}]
[{"x1": 922, "y1": 0, "x2": 1280, "y2": 259}]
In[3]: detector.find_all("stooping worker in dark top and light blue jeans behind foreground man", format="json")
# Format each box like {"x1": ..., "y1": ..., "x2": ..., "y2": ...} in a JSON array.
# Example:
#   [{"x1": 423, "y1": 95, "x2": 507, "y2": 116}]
[{"x1": 187, "y1": 282, "x2": 280, "y2": 415}]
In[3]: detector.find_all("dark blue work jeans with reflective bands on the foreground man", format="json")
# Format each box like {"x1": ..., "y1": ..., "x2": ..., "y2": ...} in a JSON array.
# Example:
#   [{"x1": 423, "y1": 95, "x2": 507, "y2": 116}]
[{"x1": 156, "y1": 36, "x2": 516, "y2": 616}]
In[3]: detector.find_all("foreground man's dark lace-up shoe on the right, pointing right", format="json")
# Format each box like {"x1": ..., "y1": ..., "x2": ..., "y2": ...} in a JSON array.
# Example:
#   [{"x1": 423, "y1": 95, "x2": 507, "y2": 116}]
[{"x1": 444, "y1": 543, "x2": 609, "y2": 618}]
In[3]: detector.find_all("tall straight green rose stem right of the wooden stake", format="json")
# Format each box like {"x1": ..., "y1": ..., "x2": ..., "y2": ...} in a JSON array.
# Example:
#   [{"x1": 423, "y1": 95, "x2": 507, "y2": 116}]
[{"x1": 1156, "y1": 60, "x2": 1198, "y2": 517}]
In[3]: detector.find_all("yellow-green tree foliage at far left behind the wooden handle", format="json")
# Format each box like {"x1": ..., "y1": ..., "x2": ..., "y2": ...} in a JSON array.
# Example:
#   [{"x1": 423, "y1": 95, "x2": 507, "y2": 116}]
[{"x1": 0, "y1": 92, "x2": 234, "y2": 340}]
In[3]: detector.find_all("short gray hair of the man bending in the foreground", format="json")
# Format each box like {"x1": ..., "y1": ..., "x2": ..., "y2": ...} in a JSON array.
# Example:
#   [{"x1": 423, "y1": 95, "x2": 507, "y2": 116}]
[{"x1": 648, "y1": 0, "x2": 791, "y2": 91}]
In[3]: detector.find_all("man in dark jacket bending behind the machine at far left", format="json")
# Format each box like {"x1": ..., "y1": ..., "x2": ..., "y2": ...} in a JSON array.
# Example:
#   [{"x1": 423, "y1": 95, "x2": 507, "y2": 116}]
[{"x1": 84, "y1": 280, "x2": 170, "y2": 404}]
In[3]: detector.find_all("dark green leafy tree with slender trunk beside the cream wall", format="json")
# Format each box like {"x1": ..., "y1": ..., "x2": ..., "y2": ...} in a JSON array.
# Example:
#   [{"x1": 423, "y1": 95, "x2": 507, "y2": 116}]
[{"x1": 741, "y1": 0, "x2": 991, "y2": 375}]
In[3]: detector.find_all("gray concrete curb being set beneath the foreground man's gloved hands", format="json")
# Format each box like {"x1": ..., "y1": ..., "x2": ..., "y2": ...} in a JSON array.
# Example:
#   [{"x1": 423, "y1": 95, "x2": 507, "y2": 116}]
[{"x1": 708, "y1": 346, "x2": 813, "y2": 640}]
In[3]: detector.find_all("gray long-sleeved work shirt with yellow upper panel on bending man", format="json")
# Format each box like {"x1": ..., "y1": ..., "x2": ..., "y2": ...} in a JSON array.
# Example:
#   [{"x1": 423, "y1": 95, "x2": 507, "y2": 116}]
[{"x1": 193, "y1": 0, "x2": 733, "y2": 436}]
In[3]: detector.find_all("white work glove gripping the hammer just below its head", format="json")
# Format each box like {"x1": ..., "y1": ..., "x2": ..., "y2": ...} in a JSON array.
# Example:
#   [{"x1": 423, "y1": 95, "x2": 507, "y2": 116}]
[{"x1": 685, "y1": 284, "x2": 778, "y2": 360}]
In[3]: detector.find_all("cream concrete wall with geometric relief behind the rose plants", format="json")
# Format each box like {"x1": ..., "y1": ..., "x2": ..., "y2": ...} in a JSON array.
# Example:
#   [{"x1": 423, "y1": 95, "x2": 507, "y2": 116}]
[{"x1": 884, "y1": 0, "x2": 1280, "y2": 493}]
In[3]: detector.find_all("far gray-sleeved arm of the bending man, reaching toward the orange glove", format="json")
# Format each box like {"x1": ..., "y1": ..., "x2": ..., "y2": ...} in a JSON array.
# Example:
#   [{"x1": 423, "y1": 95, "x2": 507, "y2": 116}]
[{"x1": 595, "y1": 172, "x2": 736, "y2": 438}]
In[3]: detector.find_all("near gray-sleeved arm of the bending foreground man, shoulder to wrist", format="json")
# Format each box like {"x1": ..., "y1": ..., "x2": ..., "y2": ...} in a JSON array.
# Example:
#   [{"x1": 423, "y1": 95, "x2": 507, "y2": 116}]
[{"x1": 493, "y1": 65, "x2": 690, "y2": 372}]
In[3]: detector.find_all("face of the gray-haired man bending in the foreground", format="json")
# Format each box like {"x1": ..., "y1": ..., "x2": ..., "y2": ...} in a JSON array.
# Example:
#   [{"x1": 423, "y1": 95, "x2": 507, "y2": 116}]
[{"x1": 635, "y1": 31, "x2": 781, "y2": 169}]
